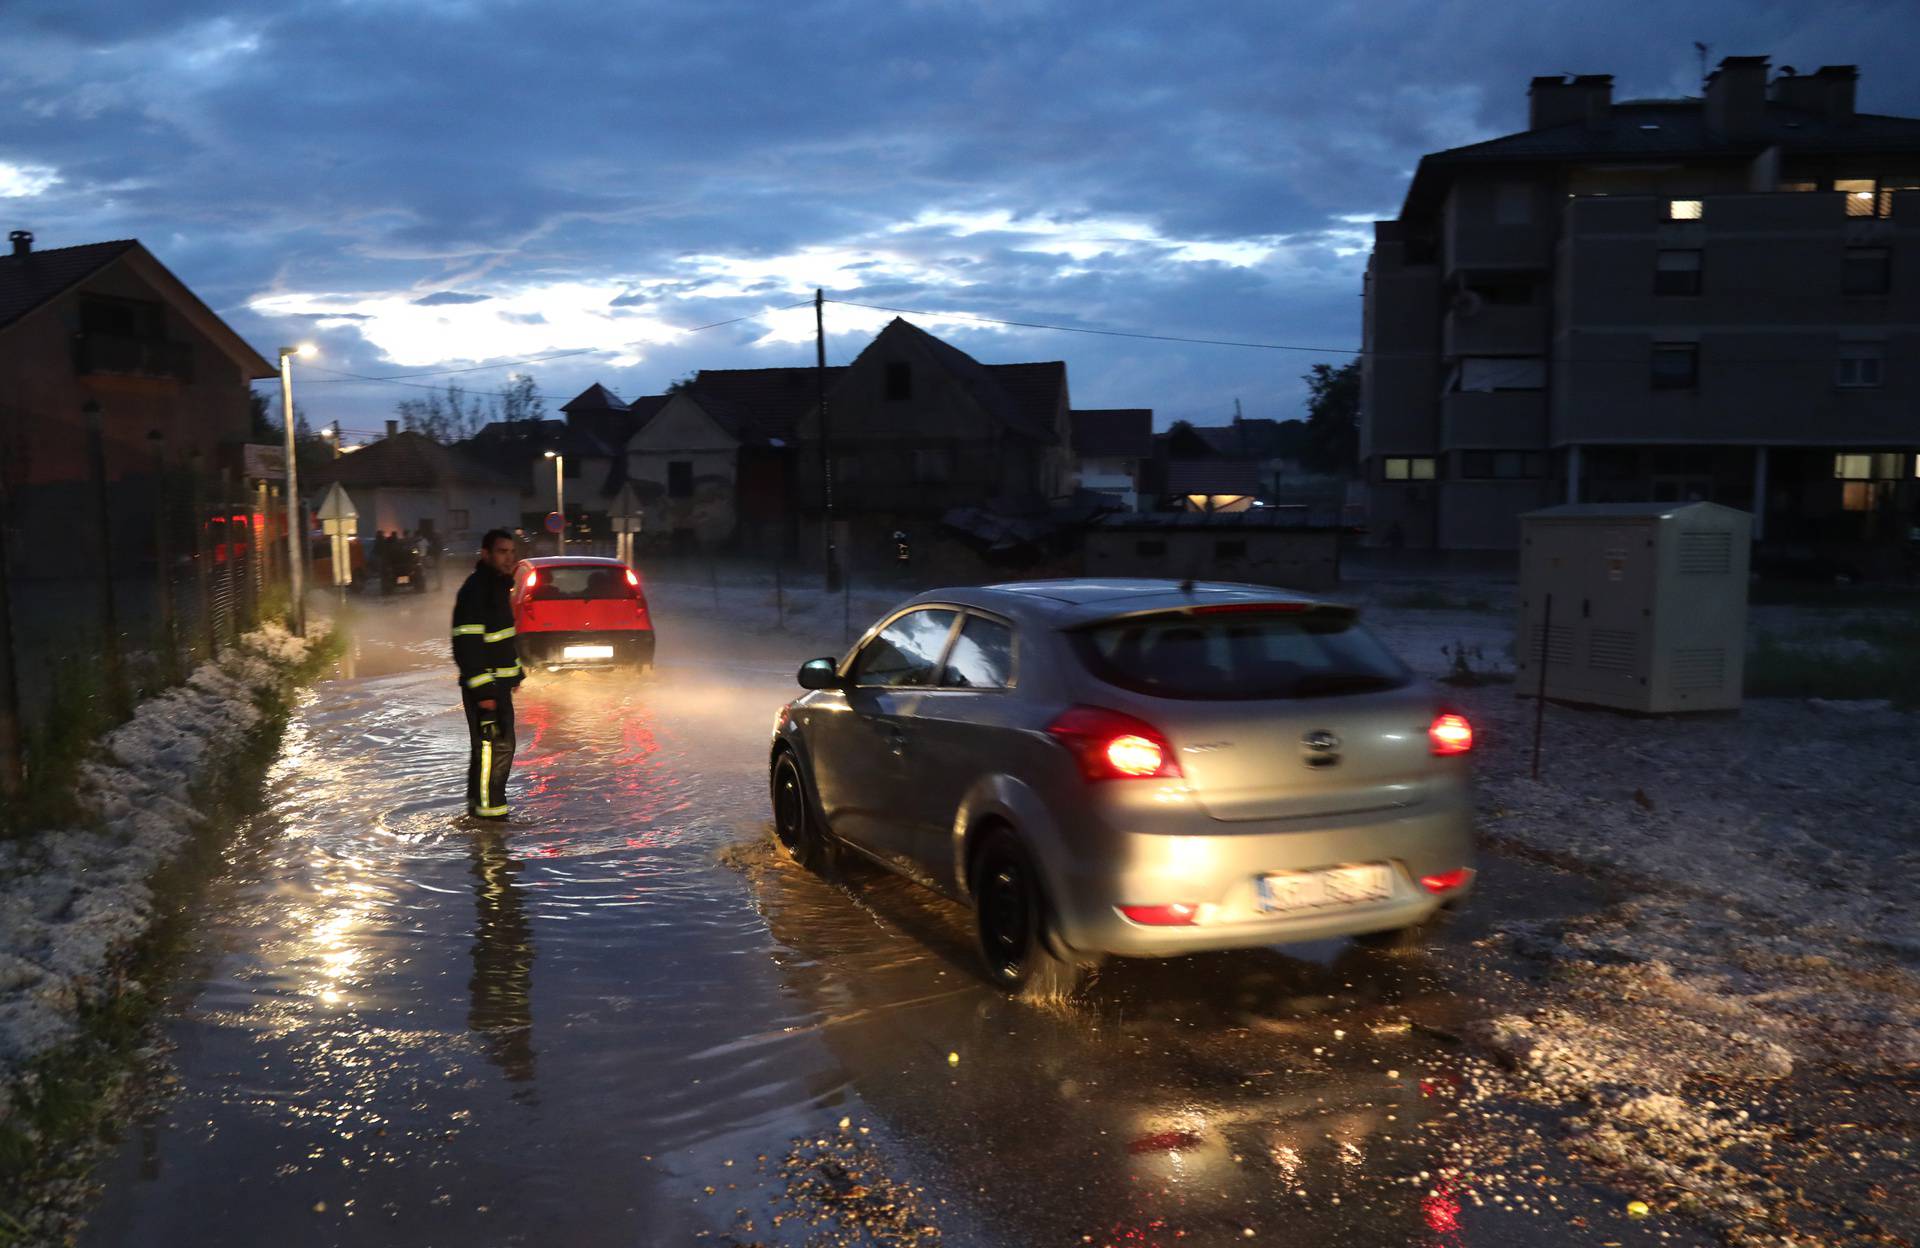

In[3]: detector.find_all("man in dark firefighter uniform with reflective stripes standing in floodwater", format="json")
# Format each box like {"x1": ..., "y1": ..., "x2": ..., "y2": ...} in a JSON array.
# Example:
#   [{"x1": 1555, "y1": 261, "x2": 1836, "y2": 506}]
[{"x1": 453, "y1": 528, "x2": 522, "y2": 820}]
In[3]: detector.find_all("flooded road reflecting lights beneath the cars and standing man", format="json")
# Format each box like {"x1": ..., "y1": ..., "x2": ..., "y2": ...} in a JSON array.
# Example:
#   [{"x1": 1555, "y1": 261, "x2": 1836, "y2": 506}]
[{"x1": 83, "y1": 589, "x2": 1692, "y2": 1248}]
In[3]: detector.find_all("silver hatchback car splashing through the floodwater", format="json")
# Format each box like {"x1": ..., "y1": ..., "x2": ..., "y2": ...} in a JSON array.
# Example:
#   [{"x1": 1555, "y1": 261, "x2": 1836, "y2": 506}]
[{"x1": 770, "y1": 580, "x2": 1473, "y2": 991}]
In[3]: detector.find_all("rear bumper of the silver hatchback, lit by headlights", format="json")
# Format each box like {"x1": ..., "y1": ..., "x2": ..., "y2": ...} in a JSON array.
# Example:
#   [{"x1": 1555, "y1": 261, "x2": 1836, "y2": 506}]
[{"x1": 1052, "y1": 787, "x2": 1473, "y2": 956}]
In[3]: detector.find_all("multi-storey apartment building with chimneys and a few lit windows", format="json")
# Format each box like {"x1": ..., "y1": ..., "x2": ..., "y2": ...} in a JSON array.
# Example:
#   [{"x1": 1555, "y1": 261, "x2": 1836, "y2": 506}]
[{"x1": 1361, "y1": 56, "x2": 1920, "y2": 566}]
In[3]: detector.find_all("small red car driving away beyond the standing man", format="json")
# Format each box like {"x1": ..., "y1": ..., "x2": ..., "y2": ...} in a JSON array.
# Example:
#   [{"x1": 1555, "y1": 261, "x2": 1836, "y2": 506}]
[{"x1": 513, "y1": 555, "x2": 653, "y2": 672}]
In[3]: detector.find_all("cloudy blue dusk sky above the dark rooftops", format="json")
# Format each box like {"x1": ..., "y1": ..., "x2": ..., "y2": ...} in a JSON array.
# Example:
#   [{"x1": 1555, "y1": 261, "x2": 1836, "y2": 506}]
[{"x1": 0, "y1": 0, "x2": 1920, "y2": 439}]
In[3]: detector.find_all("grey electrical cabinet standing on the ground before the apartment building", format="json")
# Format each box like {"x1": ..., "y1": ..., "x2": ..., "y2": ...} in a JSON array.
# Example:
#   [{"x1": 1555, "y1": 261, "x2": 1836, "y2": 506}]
[{"x1": 1515, "y1": 503, "x2": 1753, "y2": 712}]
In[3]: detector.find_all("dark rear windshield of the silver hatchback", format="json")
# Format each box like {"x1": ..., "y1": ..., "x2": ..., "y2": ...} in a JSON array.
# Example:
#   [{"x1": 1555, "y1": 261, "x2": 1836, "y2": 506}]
[{"x1": 1069, "y1": 611, "x2": 1409, "y2": 701}]
